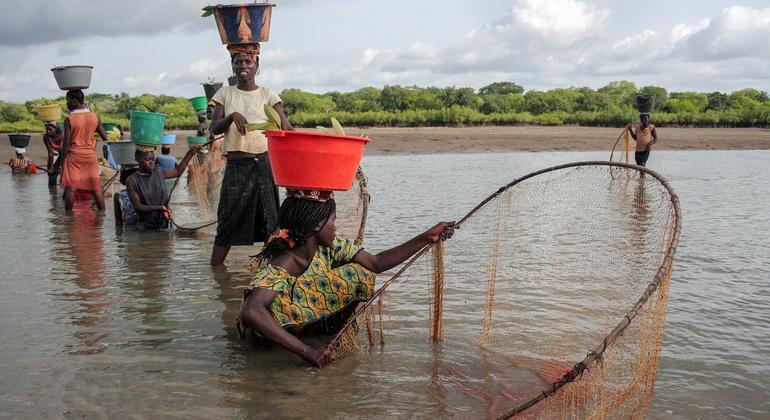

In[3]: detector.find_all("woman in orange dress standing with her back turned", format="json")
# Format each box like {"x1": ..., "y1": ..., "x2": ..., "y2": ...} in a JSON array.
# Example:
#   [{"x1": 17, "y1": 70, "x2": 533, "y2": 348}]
[{"x1": 61, "y1": 90, "x2": 107, "y2": 211}]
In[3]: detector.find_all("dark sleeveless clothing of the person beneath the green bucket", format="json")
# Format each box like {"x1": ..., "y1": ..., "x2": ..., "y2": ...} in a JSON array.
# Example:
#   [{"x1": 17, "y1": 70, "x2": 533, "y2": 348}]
[{"x1": 126, "y1": 166, "x2": 168, "y2": 229}]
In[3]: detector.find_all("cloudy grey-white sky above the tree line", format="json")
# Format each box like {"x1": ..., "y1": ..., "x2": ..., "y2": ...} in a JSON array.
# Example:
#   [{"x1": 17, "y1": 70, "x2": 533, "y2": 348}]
[{"x1": 0, "y1": 0, "x2": 770, "y2": 102}]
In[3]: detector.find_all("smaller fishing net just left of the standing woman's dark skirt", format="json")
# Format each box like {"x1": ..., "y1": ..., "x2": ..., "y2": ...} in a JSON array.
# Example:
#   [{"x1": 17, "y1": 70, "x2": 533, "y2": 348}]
[{"x1": 169, "y1": 140, "x2": 227, "y2": 232}]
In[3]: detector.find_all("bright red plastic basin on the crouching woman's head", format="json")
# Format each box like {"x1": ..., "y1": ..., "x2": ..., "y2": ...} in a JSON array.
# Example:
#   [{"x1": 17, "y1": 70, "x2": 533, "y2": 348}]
[{"x1": 265, "y1": 131, "x2": 369, "y2": 191}]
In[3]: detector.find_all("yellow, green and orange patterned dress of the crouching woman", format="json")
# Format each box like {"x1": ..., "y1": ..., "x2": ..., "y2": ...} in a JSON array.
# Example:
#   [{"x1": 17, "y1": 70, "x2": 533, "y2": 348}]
[{"x1": 238, "y1": 237, "x2": 376, "y2": 332}]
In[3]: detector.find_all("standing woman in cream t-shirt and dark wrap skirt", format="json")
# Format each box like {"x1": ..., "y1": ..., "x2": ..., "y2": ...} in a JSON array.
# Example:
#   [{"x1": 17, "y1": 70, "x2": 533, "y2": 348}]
[{"x1": 211, "y1": 43, "x2": 294, "y2": 265}]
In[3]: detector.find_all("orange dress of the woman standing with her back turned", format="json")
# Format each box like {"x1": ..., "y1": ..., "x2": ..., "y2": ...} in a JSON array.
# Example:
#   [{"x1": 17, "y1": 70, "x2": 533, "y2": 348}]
[{"x1": 61, "y1": 110, "x2": 102, "y2": 191}]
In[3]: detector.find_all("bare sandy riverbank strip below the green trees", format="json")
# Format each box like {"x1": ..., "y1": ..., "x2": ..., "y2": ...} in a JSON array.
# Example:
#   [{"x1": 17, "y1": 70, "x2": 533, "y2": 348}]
[{"x1": 0, "y1": 126, "x2": 770, "y2": 165}]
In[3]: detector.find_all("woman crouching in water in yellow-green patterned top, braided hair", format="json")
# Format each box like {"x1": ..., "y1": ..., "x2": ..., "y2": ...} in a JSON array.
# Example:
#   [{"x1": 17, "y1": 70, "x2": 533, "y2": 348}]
[{"x1": 237, "y1": 189, "x2": 454, "y2": 366}]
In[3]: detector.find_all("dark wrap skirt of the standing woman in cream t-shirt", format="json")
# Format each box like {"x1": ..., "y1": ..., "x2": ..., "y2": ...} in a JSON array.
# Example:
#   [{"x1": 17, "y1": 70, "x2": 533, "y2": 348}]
[{"x1": 214, "y1": 153, "x2": 278, "y2": 246}]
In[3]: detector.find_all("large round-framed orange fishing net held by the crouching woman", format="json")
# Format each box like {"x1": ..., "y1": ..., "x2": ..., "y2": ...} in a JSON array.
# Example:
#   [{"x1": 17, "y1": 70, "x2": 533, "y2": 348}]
[{"x1": 326, "y1": 162, "x2": 681, "y2": 418}]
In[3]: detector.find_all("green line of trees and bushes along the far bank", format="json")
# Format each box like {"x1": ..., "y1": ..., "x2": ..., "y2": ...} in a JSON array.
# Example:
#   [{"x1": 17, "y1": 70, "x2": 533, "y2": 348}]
[{"x1": 0, "y1": 81, "x2": 770, "y2": 132}]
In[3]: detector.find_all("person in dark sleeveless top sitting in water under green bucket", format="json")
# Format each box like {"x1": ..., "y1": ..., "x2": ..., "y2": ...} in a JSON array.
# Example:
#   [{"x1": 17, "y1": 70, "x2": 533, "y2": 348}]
[{"x1": 126, "y1": 144, "x2": 202, "y2": 230}]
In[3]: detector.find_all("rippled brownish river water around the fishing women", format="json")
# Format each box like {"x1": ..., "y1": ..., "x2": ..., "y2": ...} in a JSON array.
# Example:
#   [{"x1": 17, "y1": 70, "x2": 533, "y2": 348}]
[{"x1": 0, "y1": 151, "x2": 770, "y2": 418}]
